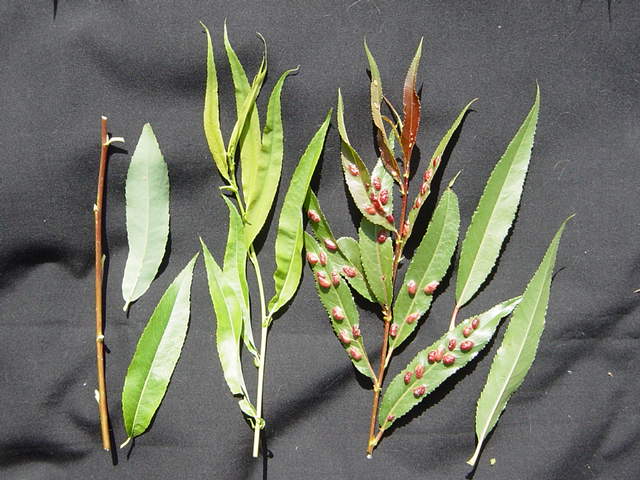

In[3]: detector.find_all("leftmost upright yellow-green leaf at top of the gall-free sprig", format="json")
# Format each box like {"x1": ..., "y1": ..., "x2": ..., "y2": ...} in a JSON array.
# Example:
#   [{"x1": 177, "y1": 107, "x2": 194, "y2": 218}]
[{"x1": 200, "y1": 22, "x2": 229, "y2": 181}]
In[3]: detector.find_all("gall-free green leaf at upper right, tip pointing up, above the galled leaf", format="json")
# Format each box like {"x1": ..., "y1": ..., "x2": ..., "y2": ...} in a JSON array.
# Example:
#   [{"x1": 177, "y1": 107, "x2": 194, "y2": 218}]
[{"x1": 456, "y1": 89, "x2": 540, "y2": 308}]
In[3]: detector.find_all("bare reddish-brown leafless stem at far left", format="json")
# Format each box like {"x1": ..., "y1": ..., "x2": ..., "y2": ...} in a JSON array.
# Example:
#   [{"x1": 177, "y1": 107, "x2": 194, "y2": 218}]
[{"x1": 93, "y1": 116, "x2": 111, "y2": 451}]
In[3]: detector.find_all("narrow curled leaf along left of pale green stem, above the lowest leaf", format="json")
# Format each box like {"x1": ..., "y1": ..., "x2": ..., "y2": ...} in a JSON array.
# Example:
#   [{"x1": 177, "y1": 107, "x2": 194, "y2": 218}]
[{"x1": 222, "y1": 196, "x2": 259, "y2": 361}]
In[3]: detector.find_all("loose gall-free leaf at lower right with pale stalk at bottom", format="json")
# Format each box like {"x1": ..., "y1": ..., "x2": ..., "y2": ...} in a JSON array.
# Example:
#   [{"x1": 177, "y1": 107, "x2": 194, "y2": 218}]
[{"x1": 468, "y1": 217, "x2": 571, "y2": 465}]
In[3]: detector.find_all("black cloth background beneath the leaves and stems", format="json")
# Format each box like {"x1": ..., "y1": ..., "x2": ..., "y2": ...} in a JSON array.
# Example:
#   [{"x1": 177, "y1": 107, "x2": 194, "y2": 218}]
[{"x1": 0, "y1": 0, "x2": 640, "y2": 480}]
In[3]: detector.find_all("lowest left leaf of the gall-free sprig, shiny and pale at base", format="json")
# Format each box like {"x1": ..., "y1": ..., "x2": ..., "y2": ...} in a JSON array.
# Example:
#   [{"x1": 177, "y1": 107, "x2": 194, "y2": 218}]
[{"x1": 200, "y1": 239, "x2": 255, "y2": 417}]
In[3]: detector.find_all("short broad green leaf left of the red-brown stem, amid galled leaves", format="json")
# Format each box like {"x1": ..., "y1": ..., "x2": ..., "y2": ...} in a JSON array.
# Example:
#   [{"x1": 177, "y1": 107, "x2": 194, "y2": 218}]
[{"x1": 359, "y1": 218, "x2": 393, "y2": 305}]
